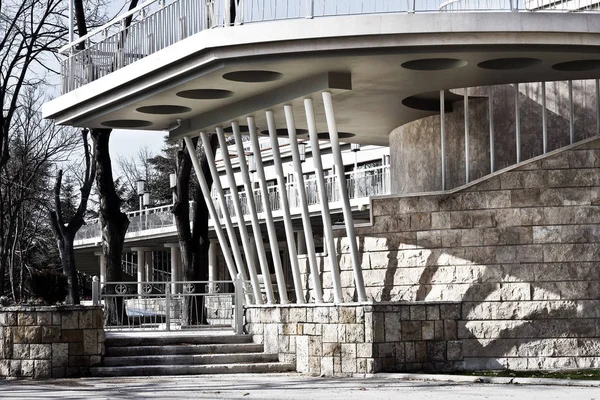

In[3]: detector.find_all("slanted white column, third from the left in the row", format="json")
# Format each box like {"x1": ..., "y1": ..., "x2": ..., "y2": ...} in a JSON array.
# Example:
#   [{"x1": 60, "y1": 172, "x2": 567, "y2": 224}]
[{"x1": 216, "y1": 126, "x2": 262, "y2": 304}]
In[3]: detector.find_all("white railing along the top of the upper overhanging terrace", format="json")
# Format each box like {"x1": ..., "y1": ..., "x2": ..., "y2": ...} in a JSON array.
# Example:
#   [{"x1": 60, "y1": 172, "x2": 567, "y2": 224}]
[{"x1": 61, "y1": 0, "x2": 600, "y2": 93}]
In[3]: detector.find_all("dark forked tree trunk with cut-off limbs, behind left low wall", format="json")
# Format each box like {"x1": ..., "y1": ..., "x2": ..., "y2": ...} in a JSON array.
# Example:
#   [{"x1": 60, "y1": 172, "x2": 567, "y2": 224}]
[{"x1": 50, "y1": 129, "x2": 96, "y2": 304}]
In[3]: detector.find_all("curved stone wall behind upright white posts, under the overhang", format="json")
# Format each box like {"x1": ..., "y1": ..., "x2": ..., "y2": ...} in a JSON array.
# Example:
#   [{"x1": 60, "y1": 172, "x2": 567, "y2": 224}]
[{"x1": 390, "y1": 80, "x2": 597, "y2": 194}]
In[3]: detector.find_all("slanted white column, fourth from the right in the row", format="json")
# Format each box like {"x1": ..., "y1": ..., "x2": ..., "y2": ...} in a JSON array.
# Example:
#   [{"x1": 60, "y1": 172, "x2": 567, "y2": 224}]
[{"x1": 266, "y1": 111, "x2": 304, "y2": 304}]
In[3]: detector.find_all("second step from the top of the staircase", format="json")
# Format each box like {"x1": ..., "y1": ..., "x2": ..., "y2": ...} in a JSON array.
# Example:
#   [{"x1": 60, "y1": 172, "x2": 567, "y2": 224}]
[{"x1": 105, "y1": 343, "x2": 263, "y2": 357}]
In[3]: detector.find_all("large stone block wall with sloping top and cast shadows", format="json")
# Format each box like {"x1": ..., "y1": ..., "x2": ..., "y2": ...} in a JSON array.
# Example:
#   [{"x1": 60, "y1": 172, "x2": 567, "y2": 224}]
[{"x1": 296, "y1": 139, "x2": 600, "y2": 369}]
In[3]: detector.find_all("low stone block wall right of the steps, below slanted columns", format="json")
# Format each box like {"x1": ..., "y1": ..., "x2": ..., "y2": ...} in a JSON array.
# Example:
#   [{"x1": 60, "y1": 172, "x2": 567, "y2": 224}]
[{"x1": 246, "y1": 303, "x2": 463, "y2": 376}]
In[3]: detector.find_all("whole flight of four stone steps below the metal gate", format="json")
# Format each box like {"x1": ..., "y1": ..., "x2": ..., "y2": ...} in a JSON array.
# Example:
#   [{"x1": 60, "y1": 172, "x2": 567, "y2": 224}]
[{"x1": 91, "y1": 333, "x2": 295, "y2": 376}]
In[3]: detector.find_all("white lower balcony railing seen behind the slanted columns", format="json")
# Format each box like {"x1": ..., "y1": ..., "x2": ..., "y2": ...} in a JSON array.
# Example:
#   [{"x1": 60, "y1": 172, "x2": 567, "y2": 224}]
[{"x1": 75, "y1": 165, "x2": 390, "y2": 245}]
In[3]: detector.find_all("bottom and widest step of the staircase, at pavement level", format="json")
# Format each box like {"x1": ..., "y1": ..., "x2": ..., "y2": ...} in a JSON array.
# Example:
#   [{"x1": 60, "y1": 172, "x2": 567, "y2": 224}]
[{"x1": 91, "y1": 362, "x2": 295, "y2": 376}]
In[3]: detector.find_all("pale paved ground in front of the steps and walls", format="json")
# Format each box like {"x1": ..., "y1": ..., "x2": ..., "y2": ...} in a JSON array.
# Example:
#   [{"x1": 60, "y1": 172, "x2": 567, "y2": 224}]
[{"x1": 0, "y1": 374, "x2": 600, "y2": 400}]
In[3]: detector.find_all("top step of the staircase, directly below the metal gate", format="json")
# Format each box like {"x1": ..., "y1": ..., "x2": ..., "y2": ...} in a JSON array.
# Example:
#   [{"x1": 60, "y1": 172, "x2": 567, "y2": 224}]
[{"x1": 105, "y1": 334, "x2": 252, "y2": 347}]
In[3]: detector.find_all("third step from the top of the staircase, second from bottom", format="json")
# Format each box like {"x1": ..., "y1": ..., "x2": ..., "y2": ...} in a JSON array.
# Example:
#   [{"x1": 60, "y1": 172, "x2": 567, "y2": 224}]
[{"x1": 102, "y1": 353, "x2": 278, "y2": 367}]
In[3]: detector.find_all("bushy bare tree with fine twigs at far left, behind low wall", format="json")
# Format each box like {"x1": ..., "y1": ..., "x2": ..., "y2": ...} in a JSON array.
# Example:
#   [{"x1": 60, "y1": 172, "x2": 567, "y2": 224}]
[{"x1": 0, "y1": 88, "x2": 78, "y2": 301}]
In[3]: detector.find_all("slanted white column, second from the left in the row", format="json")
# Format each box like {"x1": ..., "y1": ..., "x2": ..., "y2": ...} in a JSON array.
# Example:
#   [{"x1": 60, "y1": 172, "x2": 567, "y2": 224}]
[{"x1": 200, "y1": 132, "x2": 251, "y2": 300}]
